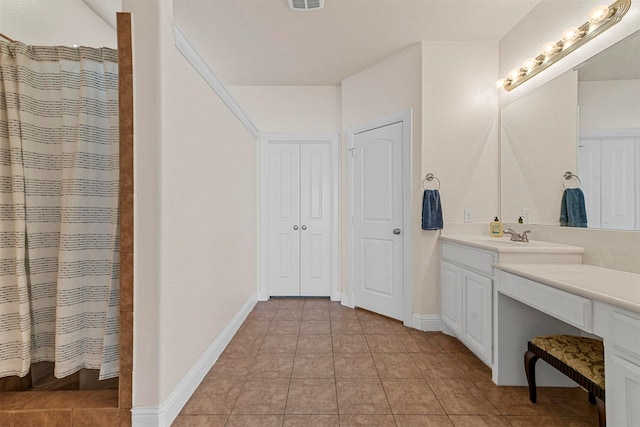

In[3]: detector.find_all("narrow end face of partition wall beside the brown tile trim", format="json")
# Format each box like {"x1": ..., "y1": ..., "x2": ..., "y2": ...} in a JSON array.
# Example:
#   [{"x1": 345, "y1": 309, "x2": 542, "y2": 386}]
[{"x1": 122, "y1": 0, "x2": 164, "y2": 406}]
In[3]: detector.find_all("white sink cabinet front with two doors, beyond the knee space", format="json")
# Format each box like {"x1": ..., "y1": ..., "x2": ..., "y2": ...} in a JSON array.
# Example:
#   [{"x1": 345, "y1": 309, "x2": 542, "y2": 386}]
[{"x1": 441, "y1": 242, "x2": 497, "y2": 366}]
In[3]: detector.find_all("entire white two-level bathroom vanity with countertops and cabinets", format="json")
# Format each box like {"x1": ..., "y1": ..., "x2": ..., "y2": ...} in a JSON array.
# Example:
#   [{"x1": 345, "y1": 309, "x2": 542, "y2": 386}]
[{"x1": 441, "y1": 236, "x2": 640, "y2": 426}]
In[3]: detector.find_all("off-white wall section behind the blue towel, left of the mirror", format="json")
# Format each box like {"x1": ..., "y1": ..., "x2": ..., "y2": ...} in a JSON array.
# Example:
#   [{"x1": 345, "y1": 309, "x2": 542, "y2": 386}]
[{"x1": 414, "y1": 42, "x2": 499, "y2": 314}]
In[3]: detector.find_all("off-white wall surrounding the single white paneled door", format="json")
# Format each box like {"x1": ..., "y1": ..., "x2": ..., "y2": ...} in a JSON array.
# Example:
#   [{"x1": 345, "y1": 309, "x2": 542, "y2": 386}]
[{"x1": 341, "y1": 44, "x2": 422, "y2": 312}]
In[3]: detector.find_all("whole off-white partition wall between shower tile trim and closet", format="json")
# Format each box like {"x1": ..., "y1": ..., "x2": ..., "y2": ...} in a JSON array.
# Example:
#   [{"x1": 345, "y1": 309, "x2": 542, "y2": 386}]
[{"x1": 123, "y1": 1, "x2": 257, "y2": 410}]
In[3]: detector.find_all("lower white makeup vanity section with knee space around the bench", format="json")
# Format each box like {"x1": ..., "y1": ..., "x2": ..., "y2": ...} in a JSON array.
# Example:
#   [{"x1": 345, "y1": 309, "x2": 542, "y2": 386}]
[{"x1": 493, "y1": 263, "x2": 640, "y2": 427}]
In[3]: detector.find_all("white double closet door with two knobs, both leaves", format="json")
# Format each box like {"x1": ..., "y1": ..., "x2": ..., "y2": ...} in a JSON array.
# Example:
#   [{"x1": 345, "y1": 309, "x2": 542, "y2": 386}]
[{"x1": 266, "y1": 142, "x2": 332, "y2": 296}]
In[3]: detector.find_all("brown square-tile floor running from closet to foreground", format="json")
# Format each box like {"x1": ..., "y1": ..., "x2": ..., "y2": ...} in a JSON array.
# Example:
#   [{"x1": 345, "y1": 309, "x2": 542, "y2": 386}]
[{"x1": 173, "y1": 299, "x2": 598, "y2": 427}]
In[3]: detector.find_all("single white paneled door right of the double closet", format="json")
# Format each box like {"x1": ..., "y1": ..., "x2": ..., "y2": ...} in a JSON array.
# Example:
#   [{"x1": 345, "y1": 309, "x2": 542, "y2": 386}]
[{"x1": 352, "y1": 122, "x2": 404, "y2": 319}]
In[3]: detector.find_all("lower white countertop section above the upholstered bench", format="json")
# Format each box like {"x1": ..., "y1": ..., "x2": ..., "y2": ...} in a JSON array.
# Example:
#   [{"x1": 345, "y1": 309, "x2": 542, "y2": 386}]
[{"x1": 494, "y1": 263, "x2": 640, "y2": 313}]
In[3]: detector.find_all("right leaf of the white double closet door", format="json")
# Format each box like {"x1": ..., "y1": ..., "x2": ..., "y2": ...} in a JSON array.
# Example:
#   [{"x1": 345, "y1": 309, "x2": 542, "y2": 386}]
[{"x1": 299, "y1": 143, "x2": 331, "y2": 296}]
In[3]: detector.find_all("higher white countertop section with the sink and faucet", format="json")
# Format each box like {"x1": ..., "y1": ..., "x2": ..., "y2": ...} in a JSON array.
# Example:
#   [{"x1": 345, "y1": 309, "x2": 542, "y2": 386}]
[{"x1": 440, "y1": 234, "x2": 584, "y2": 254}]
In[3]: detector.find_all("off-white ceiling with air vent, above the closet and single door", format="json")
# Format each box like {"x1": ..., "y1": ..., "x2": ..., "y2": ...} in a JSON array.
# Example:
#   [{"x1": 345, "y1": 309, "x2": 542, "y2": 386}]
[{"x1": 173, "y1": 0, "x2": 541, "y2": 85}]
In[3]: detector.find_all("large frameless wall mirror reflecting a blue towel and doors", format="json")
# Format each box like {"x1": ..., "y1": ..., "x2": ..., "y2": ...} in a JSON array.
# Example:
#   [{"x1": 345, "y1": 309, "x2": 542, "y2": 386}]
[{"x1": 500, "y1": 31, "x2": 640, "y2": 230}]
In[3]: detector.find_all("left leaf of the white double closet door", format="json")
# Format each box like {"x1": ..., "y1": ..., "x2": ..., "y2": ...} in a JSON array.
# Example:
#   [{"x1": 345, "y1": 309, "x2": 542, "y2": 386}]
[{"x1": 267, "y1": 143, "x2": 300, "y2": 296}]
